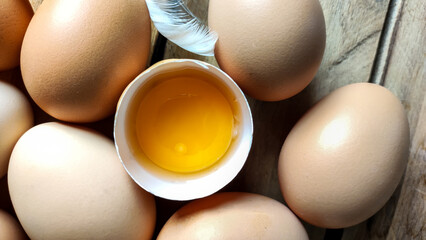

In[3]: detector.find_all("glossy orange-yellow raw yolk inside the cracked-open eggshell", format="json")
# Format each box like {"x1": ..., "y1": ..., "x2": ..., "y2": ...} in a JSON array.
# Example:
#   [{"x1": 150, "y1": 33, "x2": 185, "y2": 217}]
[{"x1": 136, "y1": 77, "x2": 234, "y2": 173}]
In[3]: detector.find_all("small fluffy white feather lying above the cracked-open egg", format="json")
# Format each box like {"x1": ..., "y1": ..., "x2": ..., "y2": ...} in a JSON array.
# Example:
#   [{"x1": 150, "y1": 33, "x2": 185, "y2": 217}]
[{"x1": 145, "y1": 0, "x2": 217, "y2": 56}]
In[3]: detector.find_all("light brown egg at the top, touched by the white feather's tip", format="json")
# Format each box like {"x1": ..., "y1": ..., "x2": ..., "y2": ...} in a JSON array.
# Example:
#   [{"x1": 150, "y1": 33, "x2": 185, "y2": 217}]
[{"x1": 208, "y1": 0, "x2": 326, "y2": 101}]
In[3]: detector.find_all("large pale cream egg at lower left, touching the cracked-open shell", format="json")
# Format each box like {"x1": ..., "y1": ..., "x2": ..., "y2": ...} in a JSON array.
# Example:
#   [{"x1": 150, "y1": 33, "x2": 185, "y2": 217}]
[{"x1": 8, "y1": 122, "x2": 156, "y2": 240}]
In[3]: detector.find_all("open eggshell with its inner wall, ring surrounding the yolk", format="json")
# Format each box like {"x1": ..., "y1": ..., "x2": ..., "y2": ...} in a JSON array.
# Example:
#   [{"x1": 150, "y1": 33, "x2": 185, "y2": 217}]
[{"x1": 114, "y1": 59, "x2": 253, "y2": 201}]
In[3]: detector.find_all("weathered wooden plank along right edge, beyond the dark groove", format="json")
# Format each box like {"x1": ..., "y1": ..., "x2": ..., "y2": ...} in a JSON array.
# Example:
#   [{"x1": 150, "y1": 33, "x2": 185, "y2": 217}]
[{"x1": 383, "y1": 0, "x2": 426, "y2": 239}]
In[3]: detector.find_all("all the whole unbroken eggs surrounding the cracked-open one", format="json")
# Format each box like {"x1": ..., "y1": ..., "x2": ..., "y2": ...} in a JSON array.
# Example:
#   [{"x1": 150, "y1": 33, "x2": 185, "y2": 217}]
[{"x1": 0, "y1": 0, "x2": 409, "y2": 240}]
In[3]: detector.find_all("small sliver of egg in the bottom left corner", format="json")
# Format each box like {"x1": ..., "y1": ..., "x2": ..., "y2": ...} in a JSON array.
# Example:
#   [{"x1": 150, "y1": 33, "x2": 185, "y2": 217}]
[{"x1": 0, "y1": 209, "x2": 26, "y2": 240}]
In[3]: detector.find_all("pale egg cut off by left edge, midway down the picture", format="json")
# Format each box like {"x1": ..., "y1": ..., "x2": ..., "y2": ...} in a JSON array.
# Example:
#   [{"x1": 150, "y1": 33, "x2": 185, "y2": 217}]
[{"x1": 0, "y1": 81, "x2": 33, "y2": 178}]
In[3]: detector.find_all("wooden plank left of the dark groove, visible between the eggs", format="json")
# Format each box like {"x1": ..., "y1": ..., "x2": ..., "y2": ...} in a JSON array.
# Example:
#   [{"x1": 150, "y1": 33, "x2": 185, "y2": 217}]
[{"x1": 161, "y1": 0, "x2": 389, "y2": 239}]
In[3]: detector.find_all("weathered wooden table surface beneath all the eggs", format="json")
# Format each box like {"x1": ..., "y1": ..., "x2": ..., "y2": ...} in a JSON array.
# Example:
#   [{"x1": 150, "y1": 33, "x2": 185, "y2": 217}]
[{"x1": 0, "y1": 0, "x2": 426, "y2": 240}]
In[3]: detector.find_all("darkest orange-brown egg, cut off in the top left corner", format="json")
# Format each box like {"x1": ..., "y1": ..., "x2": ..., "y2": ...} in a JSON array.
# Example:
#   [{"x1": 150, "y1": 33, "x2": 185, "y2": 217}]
[{"x1": 0, "y1": 0, "x2": 33, "y2": 71}]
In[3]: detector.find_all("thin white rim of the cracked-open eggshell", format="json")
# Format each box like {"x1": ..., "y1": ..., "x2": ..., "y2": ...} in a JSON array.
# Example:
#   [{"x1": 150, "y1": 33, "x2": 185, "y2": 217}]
[{"x1": 113, "y1": 59, "x2": 253, "y2": 201}]
